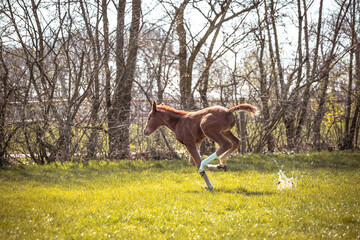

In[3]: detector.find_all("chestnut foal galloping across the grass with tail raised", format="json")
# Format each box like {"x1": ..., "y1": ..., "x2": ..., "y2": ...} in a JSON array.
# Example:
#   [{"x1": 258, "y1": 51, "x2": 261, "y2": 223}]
[{"x1": 144, "y1": 101, "x2": 257, "y2": 190}]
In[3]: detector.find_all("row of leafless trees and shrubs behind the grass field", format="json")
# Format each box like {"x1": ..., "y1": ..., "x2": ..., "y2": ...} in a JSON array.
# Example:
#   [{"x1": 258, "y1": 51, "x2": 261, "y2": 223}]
[{"x1": 0, "y1": 0, "x2": 360, "y2": 165}]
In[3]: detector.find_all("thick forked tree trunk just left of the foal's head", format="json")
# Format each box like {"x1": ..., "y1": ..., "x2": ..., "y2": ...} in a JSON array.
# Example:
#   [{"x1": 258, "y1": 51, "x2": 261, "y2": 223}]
[{"x1": 109, "y1": 0, "x2": 141, "y2": 159}]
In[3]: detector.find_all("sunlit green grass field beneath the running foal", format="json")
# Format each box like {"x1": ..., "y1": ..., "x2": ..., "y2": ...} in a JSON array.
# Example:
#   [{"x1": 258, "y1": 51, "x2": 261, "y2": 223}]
[{"x1": 0, "y1": 152, "x2": 360, "y2": 239}]
